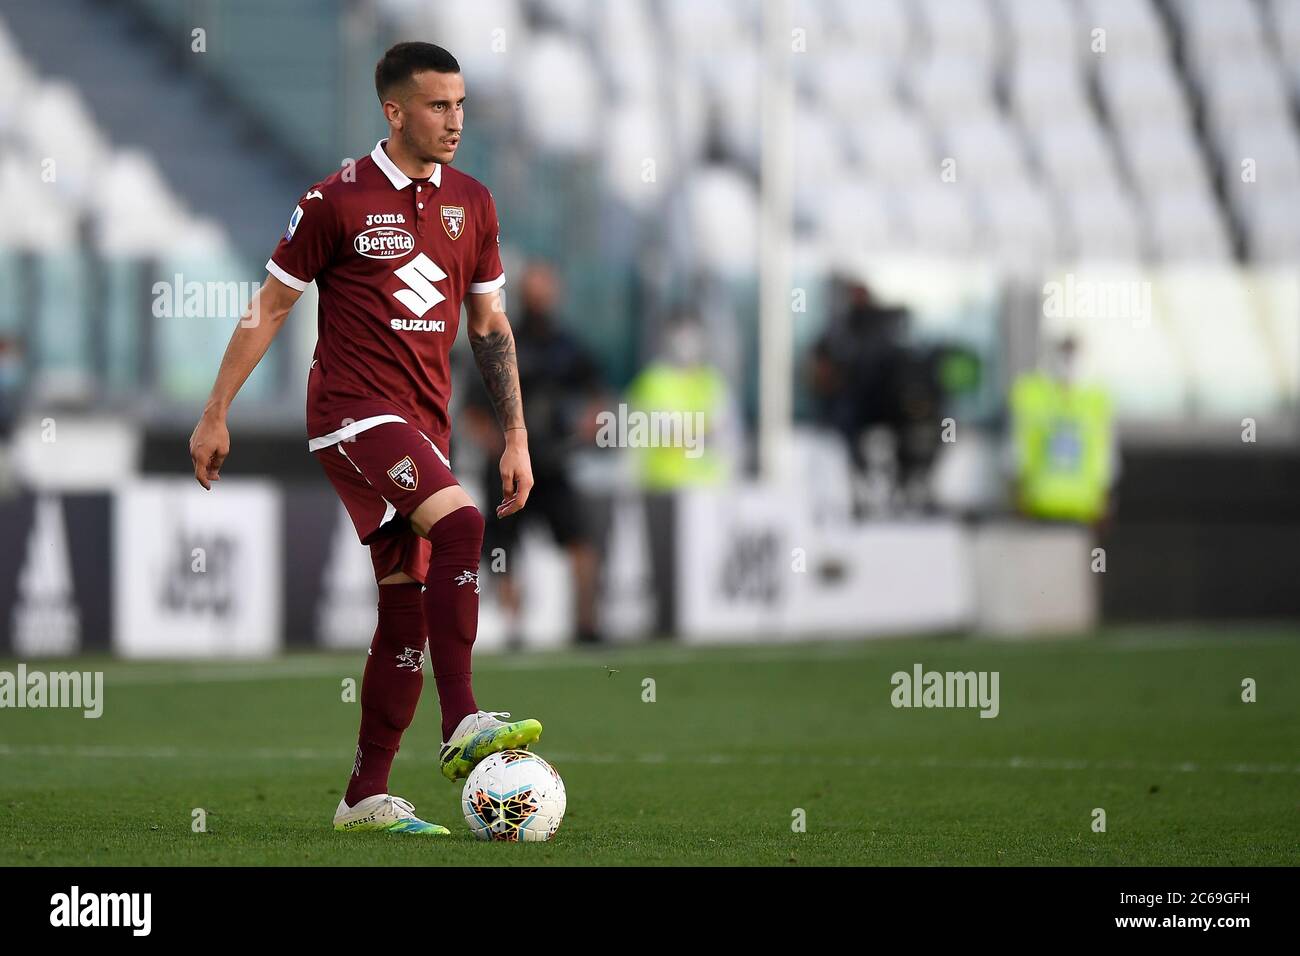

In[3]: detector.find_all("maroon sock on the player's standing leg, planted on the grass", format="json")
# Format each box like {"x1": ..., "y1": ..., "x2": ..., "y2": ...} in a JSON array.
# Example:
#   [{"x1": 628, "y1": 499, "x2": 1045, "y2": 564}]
[{"x1": 343, "y1": 583, "x2": 424, "y2": 806}]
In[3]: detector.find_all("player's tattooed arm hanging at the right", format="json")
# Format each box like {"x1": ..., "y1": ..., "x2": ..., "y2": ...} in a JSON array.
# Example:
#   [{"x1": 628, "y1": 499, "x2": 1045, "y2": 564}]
[{"x1": 465, "y1": 289, "x2": 533, "y2": 518}]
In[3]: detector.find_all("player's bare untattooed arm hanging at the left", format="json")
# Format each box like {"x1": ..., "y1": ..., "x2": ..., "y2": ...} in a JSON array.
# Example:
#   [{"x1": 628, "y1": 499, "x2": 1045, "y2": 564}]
[{"x1": 190, "y1": 274, "x2": 302, "y2": 490}]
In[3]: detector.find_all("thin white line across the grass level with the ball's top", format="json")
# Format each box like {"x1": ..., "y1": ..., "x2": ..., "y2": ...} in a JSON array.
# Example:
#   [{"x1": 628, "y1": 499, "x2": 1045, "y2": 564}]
[{"x1": 0, "y1": 744, "x2": 1300, "y2": 774}]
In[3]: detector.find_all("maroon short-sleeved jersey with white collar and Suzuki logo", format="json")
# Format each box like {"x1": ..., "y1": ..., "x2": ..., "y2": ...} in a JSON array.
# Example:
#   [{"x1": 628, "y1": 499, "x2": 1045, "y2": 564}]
[{"x1": 267, "y1": 140, "x2": 506, "y2": 455}]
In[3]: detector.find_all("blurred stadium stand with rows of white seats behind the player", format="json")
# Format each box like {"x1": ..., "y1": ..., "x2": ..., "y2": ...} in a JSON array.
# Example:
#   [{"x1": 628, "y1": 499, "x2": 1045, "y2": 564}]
[{"x1": 0, "y1": 0, "x2": 1300, "y2": 420}]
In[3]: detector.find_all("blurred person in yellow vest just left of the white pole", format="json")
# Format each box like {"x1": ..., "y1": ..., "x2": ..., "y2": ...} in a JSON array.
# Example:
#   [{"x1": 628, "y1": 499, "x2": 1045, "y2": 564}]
[{"x1": 627, "y1": 311, "x2": 740, "y2": 637}]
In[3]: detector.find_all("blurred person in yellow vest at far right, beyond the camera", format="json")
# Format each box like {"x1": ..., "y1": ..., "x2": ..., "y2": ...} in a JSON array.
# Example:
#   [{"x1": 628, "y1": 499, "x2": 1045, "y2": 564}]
[{"x1": 1010, "y1": 338, "x2": 1118, "y2": 524}]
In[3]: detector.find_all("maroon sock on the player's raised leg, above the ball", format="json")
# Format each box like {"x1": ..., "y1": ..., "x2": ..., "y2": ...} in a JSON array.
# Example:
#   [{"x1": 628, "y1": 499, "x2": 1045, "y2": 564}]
[{"x1": 424, "y1": 505, "x2": 484, "y2": 740}]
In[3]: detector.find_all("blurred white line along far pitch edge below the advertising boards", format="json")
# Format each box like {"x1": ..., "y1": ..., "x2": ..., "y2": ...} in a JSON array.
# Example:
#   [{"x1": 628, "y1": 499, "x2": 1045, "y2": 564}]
[{"x1": 61, "y1": 637, "x2": 1288, "y2": 687}]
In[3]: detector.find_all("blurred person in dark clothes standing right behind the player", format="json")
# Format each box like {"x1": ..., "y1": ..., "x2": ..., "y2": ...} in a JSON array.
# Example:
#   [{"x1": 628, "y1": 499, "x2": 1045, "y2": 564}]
[{"x1": 464, "y1": 261, "x2": 608, "y2": 648}]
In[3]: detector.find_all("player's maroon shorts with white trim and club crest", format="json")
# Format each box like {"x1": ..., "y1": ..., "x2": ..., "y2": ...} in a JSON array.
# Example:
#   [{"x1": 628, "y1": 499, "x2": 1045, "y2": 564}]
[{"x1": 315, "y1": 421, "x2": 459, "y2": 583}]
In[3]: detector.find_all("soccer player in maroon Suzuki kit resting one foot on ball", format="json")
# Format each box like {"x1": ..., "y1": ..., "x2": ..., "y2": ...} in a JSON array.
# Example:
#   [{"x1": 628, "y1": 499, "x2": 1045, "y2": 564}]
[{"x1": 190, "y1": 43, "x2": 542, "y2": 834}]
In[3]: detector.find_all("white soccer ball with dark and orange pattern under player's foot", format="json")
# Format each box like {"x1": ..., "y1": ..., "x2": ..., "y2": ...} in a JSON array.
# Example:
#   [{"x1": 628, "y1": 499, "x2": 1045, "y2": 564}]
[{"x1": 460, "y1": 750, "x2": 568, "y2": 843}]
